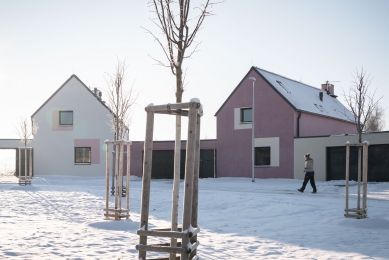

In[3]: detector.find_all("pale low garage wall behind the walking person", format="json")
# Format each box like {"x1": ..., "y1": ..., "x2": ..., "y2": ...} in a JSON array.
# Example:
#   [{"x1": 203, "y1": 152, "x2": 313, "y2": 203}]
[{"x1": 294, "y1": 132, "x2": 389, "y2": 181}]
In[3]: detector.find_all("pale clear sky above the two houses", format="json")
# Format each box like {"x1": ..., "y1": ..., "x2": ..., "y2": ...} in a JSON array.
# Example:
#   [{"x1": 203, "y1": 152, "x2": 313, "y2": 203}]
[{"x1": 0, "y1": 0, "x2": 389, "y2": 141}]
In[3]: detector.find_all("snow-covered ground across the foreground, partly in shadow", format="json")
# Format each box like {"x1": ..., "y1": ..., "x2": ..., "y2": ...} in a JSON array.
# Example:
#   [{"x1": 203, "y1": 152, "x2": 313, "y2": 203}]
[{"x1": 0, "y1": 176, "x2": 389, "y2": 259}]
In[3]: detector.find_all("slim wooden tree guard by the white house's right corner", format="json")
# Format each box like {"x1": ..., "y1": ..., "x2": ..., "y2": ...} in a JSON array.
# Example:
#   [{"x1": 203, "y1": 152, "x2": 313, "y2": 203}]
[{"x1": 104, "y1": 140, "x2": 131, "y2": 220}]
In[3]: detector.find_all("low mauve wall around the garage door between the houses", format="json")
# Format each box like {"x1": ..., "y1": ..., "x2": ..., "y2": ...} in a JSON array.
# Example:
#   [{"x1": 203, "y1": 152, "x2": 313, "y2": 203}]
[{"x1": 130, "y1": 139, "x2": 216, "y2": 177}]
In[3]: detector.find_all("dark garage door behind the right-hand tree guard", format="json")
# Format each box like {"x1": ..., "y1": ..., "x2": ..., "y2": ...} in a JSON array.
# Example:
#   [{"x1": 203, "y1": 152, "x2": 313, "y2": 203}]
[{"x1": 327, "y1": 144, "x2": 389, "y2": 181}]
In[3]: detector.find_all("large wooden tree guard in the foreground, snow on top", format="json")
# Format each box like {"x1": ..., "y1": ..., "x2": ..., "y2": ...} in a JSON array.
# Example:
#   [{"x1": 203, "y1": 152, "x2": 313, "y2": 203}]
[{"x1": 136, "y1": 99, "x2": 203, "y2": 260}]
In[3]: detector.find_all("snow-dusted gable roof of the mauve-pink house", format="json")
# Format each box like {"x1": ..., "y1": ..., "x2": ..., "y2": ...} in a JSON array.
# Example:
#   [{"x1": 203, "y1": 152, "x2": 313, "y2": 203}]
[{"x1": 215, "y1": 67, "x2": 354, "y2": 123}]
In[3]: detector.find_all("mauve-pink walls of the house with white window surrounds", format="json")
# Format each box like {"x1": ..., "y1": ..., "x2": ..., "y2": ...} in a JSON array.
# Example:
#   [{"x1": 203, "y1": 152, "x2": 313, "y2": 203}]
[{"x1": 215, "y1": 67, "x2": 355, "y2": 178}]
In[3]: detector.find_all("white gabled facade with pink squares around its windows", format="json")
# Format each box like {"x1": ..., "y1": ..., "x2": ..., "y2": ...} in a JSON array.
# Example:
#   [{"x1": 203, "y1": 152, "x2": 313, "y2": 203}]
[{"x1": 32, "y1": 75, "x2": 114, "y2": 176}]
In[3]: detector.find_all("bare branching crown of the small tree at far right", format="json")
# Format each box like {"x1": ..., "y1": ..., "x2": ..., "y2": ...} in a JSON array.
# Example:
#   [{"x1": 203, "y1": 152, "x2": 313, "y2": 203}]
[{"x1": 343, "y1": 67, "x2": 382, "y2": 143}]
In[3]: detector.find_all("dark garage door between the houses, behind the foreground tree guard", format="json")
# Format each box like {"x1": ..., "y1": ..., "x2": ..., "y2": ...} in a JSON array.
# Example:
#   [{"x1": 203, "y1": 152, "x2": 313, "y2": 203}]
[{"x1": 151, "y1": 150, "x2": 215, "y2": 179}]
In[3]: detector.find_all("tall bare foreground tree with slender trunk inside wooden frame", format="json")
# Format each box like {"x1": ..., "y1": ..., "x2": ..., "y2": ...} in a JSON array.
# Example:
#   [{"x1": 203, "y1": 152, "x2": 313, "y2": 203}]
[{"x1": 145, "y1": 0, "x2": 221, "y2": 259}]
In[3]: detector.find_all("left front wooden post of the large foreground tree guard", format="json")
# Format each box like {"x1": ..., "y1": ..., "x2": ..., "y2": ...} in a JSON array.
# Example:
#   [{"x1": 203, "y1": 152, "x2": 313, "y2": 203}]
[{"x1": 138, "y1": 112, "x2": 154, "y2": 260}]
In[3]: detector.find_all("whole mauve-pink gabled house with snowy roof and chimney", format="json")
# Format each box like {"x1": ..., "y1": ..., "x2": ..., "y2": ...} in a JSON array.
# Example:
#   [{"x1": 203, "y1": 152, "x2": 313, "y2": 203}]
[{"x1": 215, "y1": 67, "x2": 355, "y2": 178}]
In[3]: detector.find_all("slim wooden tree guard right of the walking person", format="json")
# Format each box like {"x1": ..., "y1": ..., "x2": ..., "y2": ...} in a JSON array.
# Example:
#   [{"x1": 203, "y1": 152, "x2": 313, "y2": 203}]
[{"x1": 344, "y1": 141, "x2": 369, "y2": 219}]
